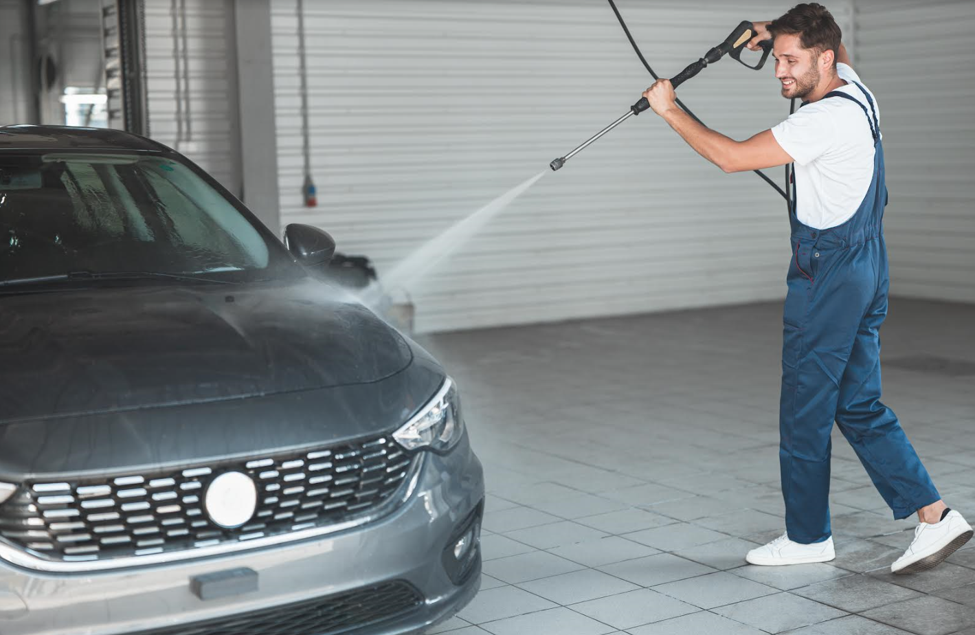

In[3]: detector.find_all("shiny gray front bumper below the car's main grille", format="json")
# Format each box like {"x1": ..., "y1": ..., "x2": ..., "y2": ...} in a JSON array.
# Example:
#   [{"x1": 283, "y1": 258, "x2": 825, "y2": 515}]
[{"x1": 0, "y1": 434, "x2": 484, "y2": 635}]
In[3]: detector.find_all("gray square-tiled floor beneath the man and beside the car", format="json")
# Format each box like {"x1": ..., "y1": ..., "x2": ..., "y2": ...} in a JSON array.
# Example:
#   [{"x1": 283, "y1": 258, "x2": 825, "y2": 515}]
[{"x1": 421, "y1": 299, "x2": 975, "y2": 635}]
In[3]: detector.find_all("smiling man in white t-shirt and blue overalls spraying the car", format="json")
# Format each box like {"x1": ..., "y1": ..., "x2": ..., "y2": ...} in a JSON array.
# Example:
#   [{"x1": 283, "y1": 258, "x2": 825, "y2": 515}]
[{"x1": 644, "y1": 3, "x2": 972, "y2": 573}]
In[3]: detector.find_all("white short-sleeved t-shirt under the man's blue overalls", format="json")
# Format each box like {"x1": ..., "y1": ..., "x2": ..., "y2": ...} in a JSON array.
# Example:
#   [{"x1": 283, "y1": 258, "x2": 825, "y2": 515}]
[{"x1": 772, "y1": 64, "x2": 880, "y2": 229}]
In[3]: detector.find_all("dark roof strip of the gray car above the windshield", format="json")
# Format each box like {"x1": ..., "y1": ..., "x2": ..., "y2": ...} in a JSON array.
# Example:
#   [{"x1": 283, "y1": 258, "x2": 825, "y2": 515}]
[{"x1": 0, "y1": 125, "x2": 171, "y2": 152}]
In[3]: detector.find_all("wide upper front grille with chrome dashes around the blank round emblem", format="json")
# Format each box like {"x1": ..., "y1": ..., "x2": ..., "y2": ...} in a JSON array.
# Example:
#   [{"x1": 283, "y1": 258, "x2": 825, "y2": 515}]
[{"x1": 0, "y1": 436, "x2": 412, "y2": 562}]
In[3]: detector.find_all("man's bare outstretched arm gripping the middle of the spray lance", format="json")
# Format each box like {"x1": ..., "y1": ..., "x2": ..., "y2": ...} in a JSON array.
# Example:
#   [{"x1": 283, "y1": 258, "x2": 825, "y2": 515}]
[{"x1": 643, "y1": 79, "x2": 792, "y2": 172}]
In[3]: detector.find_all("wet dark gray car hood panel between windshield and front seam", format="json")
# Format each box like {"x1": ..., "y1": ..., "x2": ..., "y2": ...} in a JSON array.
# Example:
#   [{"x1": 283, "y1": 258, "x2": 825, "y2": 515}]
[{"x1": 0, "y1": 279, "x2": 412, "y2": 424}]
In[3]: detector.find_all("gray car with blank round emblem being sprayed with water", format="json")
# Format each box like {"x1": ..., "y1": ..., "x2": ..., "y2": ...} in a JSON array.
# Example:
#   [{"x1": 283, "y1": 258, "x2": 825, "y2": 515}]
[{"x1": 0, "y1": 126, "x2": 484, "y2": 635}]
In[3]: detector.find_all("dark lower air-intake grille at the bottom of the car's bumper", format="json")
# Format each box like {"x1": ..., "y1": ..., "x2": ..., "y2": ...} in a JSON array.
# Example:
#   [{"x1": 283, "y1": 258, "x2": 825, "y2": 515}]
[{"x1": 137, "y1": 582, "x2": 423, "y2": 635}]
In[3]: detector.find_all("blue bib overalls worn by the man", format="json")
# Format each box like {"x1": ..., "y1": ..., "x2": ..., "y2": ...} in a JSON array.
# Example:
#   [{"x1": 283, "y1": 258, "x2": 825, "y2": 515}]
[{"x1": 779, "y1": 82, "x2": 941, "y2": 543}]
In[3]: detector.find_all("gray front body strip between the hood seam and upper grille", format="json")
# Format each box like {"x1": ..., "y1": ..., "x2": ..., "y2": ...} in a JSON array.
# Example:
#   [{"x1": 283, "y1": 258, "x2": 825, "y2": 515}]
[{"x1": 0, "y1": 358, "x2": 445, "y2": 483}]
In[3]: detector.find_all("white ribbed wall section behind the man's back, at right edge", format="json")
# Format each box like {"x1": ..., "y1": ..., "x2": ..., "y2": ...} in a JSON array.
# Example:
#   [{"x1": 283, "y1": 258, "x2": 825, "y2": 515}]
[{"x1": 854, "y1": 0, "x2": 975, "y2": 302}]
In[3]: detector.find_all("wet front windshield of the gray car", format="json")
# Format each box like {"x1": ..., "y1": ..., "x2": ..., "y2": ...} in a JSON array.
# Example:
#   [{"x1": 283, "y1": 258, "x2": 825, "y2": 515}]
[{"x1": 0, "y1": 153, "x2": 296, "y2": 283}]
